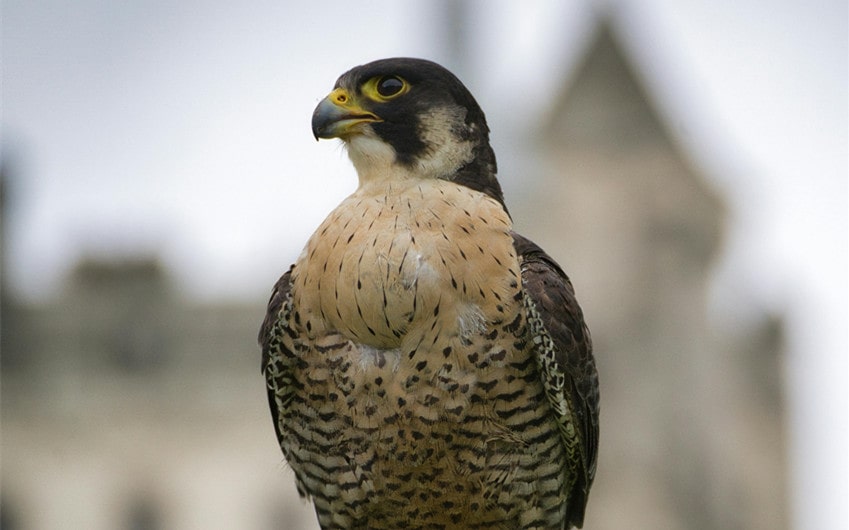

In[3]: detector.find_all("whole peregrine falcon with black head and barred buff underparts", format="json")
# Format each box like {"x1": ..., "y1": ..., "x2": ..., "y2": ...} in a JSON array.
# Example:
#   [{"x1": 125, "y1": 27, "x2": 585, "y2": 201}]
[{"x1": 259, "y1": 58, "x2": 599, "y2": 530}]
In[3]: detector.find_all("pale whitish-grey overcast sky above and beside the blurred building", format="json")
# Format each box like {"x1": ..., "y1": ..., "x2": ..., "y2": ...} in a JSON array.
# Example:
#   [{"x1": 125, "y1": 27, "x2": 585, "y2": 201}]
[{"x1": 2, "y1": 0, "x2": 849, "y2": 529}]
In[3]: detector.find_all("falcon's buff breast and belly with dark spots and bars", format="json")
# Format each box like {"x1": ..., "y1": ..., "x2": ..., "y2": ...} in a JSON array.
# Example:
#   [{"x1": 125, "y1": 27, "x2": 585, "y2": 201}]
[{"x1": 268, "y1": 181, "x2": 562, "y2": 529}]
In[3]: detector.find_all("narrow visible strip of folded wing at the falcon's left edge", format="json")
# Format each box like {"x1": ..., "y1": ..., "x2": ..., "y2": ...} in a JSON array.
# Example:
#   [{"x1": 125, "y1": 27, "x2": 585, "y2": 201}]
[{"x1": 259, "y1": 268, "x2": 292, "y2": 442}]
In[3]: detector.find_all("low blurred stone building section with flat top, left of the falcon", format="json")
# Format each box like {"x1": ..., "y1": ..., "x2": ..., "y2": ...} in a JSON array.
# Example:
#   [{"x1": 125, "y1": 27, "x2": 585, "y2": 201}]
[{"x1": 2, "y1": 254, "x2": 322, "y2": 530}]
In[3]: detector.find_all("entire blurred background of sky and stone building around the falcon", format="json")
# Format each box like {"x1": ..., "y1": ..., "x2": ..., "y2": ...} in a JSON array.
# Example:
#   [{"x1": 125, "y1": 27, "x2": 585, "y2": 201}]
[{"x1": 0, "y1": 0, "x2": 849, "y2": 530}]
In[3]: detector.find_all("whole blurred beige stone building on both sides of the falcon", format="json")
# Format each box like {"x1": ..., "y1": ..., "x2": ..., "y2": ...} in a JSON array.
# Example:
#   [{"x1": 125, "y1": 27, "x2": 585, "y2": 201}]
[{"x1": 0, "y1": 18, "x2": 788, "y2": 530}]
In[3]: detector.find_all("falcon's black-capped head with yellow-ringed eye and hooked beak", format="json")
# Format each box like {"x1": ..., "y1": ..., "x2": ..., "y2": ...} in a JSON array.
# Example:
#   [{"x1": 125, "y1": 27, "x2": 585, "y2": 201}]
[{"x1": 312, "y1": 58, "x2": 504, "y2": 205}]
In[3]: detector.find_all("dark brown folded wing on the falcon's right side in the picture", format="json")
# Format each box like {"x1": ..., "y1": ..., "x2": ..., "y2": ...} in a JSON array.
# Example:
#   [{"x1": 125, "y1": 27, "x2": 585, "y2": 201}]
[{"x1": 513, "y1": 233, "x2": 599, "y2": 528}]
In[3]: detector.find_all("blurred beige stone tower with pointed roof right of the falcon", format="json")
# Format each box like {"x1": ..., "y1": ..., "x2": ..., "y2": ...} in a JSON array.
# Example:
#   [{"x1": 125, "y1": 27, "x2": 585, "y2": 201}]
[{"x1": 513, "y1": 23, "x2": 787, "y2": 530}]
